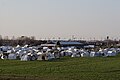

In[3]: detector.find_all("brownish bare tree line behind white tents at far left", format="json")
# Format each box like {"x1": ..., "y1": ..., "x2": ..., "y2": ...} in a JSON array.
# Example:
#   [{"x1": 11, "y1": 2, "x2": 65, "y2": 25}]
[{"x1": 0, "y1": 36, "x2": 47, "y2": 46}]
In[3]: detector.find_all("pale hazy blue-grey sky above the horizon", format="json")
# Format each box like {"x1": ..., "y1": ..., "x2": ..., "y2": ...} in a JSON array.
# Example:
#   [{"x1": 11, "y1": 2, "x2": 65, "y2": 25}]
[{"x1": 0, "y1": 0, "x2": 120, "y2": 39}]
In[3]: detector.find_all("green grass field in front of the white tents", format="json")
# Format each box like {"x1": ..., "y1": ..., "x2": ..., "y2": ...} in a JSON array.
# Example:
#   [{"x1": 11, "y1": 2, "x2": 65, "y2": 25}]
[{"x1": 0, "y1": 55, "x2": 120, "y2": 80}]
